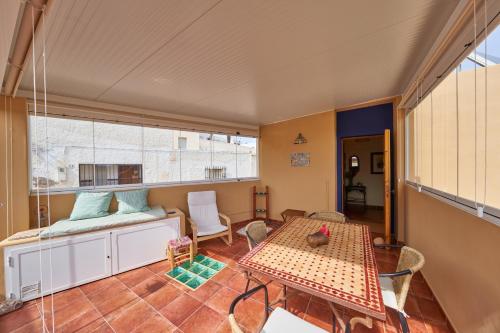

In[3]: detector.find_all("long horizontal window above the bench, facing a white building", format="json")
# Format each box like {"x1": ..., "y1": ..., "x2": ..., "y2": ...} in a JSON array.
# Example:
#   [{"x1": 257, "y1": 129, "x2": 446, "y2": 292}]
[{"x1": 30, "y1": 115, "x2": 258, "y2": 190}]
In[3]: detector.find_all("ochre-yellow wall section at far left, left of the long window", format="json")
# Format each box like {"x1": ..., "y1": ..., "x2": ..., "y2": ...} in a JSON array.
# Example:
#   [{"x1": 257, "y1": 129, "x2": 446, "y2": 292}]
[{"x1": 0, "y1": 96, "x2": 29, "y2": 239}]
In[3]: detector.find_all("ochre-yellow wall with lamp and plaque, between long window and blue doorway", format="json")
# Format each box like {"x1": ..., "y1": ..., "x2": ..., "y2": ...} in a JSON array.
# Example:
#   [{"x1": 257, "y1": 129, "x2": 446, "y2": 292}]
[{"x1": 260, "y1": 112, "x2": 336, "y2": 219}]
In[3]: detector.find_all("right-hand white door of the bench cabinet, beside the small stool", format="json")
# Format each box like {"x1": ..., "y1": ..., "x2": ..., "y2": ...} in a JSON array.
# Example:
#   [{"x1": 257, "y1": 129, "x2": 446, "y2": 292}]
[{"x1": 111, "y1": 217, "x2": 180, "y2": 275}]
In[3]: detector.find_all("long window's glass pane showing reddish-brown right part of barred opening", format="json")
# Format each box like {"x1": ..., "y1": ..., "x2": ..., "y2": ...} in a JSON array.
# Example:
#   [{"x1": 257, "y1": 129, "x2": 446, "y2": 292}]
[{"x1": 94, "y1": 122, "x2": 143, "y2": 186}]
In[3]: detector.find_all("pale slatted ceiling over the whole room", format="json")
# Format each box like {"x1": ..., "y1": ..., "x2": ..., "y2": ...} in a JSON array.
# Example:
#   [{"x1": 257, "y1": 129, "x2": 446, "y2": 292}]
[{"x1": 21, "y1": 0, "x2": 457, "y2": 124}]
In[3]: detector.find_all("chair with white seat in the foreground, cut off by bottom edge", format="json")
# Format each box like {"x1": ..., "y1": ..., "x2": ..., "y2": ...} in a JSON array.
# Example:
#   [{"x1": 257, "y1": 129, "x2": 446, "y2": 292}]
[{"x1": 229, "y1": 284, "x2": 327, "y2": 333}]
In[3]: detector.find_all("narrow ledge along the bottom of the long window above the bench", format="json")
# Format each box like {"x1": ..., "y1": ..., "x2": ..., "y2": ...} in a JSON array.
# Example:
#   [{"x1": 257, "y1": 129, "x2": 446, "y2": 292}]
[{"x1": 30, "y1": 177, "x2": 260, "y2": 196}]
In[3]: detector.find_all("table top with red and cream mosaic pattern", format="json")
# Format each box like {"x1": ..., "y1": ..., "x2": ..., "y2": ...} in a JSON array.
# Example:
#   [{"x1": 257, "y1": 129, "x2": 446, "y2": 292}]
[{"x1": 238, "y1": 217, "x2": 385, "y2": 320}]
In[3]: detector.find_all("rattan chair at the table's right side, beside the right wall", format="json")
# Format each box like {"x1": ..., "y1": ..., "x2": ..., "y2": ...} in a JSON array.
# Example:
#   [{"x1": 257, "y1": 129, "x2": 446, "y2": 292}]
[{"x1": 375, "y1": 244, "x2": 425, "y2": 333}]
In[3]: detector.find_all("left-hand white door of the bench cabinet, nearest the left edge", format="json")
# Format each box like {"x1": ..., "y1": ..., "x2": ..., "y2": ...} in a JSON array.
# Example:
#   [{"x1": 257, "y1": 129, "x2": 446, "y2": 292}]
[{"x1": 5, "y1": 232, "x2": 111, "y2": 301}]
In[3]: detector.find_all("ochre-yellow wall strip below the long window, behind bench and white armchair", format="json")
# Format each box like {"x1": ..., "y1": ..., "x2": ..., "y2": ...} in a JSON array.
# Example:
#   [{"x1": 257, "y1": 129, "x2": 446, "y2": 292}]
[{"x1": 30, "y1": 181, "x2": 258, "y2": 226}]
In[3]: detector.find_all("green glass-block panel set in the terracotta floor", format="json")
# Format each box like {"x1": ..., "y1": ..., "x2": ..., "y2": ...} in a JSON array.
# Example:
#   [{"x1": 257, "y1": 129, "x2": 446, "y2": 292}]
[{"x1": 165, "y1": 254, "x2": 226, "y2": 290}]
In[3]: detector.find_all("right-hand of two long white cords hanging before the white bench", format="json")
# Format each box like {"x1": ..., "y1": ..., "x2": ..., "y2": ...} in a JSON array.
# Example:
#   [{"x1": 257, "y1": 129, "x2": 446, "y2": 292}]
[{"x1": 42, "y1": 6, "x2": 55, "y2": 332}]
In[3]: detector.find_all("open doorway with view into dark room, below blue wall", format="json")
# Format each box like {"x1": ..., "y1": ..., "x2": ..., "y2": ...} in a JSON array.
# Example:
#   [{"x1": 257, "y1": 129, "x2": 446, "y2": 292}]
[{"x1": 342, "y1": 135, "x2": 385, "y2": 234}]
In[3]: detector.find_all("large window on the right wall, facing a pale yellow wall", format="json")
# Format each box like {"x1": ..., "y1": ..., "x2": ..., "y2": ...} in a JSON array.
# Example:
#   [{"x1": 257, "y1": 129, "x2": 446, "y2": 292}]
[{"x1": 407, "y1": 23, "x2": 500, "y2": 217}]
